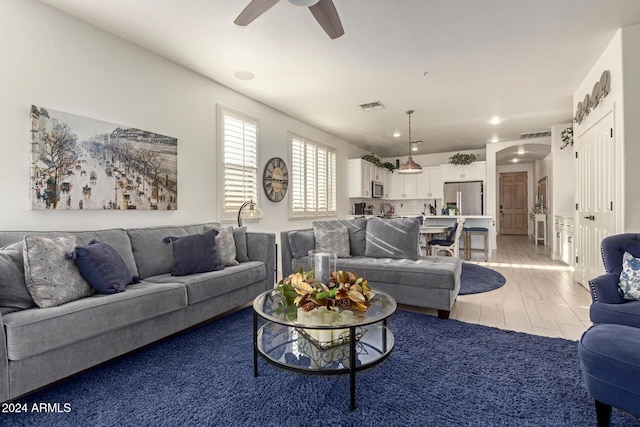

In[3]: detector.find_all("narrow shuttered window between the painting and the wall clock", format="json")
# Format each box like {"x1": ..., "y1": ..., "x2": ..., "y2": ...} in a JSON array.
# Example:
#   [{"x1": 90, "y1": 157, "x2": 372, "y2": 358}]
[{"x1": 218, "y1": 106, "x2": 258, "y2": 220}]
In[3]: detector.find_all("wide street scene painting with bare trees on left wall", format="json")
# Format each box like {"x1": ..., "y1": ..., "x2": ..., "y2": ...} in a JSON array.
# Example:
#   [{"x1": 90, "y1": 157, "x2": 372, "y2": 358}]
[{"x1": 31, "y1": 106, "x2": 178, "y2": 210}]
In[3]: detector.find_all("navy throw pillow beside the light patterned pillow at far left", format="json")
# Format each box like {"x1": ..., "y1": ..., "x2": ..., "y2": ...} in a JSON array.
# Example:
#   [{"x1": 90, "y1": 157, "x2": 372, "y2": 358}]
[{"x1": 66, "y1": 240, "x2": 140, "y2": 294}]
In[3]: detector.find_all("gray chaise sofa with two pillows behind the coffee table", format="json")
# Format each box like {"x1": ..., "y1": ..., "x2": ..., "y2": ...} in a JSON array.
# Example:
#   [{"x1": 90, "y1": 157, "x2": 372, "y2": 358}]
[{"x1": 280, "y1": 218, "x2": 462, "y2": 319}]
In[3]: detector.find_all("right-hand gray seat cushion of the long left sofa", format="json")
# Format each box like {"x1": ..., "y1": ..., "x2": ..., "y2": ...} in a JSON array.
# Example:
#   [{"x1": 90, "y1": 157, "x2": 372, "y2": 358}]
[{"x1": 146, "y1": 261, "x2": 264, "y2": 305}]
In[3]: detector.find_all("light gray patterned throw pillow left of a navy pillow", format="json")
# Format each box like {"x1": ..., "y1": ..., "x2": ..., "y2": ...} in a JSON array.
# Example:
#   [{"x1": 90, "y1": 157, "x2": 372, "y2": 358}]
[{"x1": 23, "y1": 235, "x2": 94, "y2": 308}]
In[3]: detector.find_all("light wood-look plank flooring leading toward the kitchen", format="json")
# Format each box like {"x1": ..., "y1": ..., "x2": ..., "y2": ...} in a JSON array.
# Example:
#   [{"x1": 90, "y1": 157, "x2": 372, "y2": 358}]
[{"x1": 402, "y1": 235, "x2": 591, "y2": 340}]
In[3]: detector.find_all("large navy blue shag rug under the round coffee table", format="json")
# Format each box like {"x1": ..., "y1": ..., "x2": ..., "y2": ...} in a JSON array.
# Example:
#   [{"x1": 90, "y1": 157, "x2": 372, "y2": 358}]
[{"x1": 0, "y1": 308, "x2": 639, "y2": 427}]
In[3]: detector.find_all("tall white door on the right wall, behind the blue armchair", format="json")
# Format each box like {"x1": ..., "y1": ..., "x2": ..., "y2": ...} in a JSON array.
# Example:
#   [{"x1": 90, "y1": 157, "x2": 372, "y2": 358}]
[{"x1": 575, "y1": 112, "x2": 617, "y2": 287}]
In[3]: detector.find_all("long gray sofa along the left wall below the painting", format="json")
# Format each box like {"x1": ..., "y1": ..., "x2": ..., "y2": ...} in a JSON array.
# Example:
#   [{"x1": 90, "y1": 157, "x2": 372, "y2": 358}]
[{"x1": 0, "y1": 223, "x2": 276, "y2": 401}]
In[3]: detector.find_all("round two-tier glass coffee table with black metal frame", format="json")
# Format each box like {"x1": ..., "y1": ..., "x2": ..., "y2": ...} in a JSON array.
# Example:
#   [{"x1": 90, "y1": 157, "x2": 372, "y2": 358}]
[{"x1": 253, "y1": 290, "x2": 397, "y2": 411}]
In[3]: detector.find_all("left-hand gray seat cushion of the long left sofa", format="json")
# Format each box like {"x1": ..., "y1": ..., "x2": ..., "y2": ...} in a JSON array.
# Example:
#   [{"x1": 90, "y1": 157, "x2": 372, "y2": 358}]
[{"x1": 2, "y1": 282, "x2": 187, "y2": 360}]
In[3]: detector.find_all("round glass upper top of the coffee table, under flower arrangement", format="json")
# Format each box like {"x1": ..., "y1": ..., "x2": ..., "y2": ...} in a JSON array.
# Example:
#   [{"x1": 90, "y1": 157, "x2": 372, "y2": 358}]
[{"x1": 253, "y1": 290, "x2": 397, "y2": 329}]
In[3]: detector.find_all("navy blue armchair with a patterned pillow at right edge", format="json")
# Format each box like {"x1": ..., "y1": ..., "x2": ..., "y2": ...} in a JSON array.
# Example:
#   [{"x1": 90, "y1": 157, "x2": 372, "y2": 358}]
[{"x1": 589, "y1": 233, "x2": 640, "y2": 328}]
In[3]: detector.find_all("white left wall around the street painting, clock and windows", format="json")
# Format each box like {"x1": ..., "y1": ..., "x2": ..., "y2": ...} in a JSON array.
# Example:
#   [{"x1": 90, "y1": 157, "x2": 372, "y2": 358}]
[{"x1": 0, "y1": 0, "x2": 363, "y2": 237}]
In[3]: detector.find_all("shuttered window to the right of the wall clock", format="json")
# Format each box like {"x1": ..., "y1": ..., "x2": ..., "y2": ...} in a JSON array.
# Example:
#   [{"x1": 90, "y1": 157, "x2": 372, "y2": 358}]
[{"x1": 289, "y1": 133, "x2": 336, "y2": 218}]
